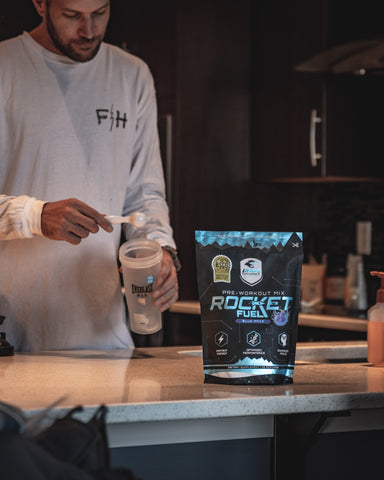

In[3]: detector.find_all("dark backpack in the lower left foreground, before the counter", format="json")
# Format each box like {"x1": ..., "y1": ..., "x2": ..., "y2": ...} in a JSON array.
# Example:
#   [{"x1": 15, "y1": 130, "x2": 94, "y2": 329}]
[{"x1": 0, "y1": 402, "x2": 139, "y2": 480}]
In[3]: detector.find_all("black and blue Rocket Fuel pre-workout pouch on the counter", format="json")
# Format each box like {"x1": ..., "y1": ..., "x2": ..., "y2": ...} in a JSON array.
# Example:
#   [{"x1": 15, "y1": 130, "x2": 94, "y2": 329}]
[{"x1": 195, "y1": 231, "x2": 303, "y2": 385}]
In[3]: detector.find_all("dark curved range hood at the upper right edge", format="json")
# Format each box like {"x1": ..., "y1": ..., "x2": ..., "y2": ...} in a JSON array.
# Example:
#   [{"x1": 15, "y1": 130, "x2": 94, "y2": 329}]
[{"x1": 295, "y1": 39, "x2": 384, "y2": 75}]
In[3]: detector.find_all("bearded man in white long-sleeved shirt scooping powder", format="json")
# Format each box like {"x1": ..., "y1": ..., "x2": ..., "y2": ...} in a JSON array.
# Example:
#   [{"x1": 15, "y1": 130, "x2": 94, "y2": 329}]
[{"x1": 0, "y1": 0, "x2": 178, "y2": 351}]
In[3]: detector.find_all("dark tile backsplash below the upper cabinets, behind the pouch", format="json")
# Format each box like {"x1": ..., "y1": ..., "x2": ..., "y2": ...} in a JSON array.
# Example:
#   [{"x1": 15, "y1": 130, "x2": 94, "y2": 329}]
[{"x1": 244, "y1": 181, "x2": 384, "y2": 306}]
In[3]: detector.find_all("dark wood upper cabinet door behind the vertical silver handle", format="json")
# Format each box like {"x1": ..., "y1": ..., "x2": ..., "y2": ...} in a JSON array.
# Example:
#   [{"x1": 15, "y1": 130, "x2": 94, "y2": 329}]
[{"x1": 252, "y1": 0, "x2": 325, "y2": 181}]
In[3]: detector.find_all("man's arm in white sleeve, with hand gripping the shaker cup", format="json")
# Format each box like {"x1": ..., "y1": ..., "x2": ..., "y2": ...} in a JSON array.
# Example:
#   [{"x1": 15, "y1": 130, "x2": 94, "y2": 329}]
[{"x1": 123, "y1": 62, "x2": 179, "y2": 312}]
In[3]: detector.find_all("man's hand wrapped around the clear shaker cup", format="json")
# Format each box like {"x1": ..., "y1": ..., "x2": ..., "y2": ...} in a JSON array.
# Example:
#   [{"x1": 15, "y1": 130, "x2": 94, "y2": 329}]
[{"x1": 152, "y1": 250, "x2": 179, "y2": 312}]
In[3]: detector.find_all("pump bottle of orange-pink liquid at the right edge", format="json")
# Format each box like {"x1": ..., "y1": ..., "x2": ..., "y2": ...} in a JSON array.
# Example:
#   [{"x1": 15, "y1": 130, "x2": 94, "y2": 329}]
[{"x1": 367, "y1": 271, "x2": 384, "y2": 367}]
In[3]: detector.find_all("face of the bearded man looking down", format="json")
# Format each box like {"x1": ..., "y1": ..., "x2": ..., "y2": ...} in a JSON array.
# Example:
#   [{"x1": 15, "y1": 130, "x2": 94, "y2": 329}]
[{"x1": 43, "y1": 0, "x2": 110, "y2": 62}]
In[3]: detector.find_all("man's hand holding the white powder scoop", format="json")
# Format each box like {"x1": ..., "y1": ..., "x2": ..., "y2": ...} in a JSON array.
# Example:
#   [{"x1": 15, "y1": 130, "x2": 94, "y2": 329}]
[{"x1": 41, "y1": 198, "x2": 113, "y2": 245}]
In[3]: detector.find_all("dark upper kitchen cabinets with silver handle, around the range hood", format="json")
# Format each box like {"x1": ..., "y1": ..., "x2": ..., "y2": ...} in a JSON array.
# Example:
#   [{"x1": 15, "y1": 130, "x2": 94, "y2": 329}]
[{"x1": 252, "y1": 0, "x2": 384, "y2": 181}]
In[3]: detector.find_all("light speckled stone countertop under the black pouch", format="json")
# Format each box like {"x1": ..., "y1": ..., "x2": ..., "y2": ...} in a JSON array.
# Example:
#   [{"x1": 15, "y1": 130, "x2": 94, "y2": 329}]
[{"x1": 0, "y1": 341, "x2": 384, "y2": 446}]
